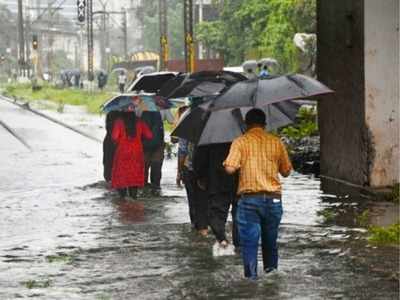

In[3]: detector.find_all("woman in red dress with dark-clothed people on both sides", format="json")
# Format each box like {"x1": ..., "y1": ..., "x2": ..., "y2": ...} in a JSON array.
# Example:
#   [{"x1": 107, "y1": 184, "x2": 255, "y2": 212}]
[{"x1": 103, "y1": 106, "x2": 164, "y2": 199}]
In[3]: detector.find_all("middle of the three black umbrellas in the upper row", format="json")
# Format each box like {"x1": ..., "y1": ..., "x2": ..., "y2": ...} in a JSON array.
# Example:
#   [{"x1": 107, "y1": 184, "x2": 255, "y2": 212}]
[{"x1": 158, "y1": 71, "x2": 247, "y2": 99}]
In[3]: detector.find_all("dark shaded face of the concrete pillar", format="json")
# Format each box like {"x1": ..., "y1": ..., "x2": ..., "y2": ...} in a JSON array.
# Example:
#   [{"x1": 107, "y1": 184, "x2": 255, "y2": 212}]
[{"x1": 317, "y1": 0, "x2": 368, "y2": 185}]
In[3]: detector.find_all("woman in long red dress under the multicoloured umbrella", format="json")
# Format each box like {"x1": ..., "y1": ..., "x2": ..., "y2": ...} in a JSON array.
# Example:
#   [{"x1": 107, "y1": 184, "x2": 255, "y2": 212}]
[{"x1": 111, "y1": 111, "x2": 153, "y2": 198}]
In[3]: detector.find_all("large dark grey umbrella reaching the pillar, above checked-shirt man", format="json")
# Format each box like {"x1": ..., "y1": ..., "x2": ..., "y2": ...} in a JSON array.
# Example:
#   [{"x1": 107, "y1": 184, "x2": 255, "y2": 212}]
[{"x1": 211, "y1": 74, "x2": 333, "y2": 110}]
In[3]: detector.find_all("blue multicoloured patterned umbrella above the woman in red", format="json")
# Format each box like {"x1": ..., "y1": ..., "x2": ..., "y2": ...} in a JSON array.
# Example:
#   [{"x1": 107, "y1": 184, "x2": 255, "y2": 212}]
[{"x1": 100, "y1": 94, "x2": 173, "y2": 113}]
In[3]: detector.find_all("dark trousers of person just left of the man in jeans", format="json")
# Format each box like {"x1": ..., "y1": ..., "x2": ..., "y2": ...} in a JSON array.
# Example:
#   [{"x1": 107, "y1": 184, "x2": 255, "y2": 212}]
[{"x1": 209, "y1": 192, "x2": 235, "y2": 242}]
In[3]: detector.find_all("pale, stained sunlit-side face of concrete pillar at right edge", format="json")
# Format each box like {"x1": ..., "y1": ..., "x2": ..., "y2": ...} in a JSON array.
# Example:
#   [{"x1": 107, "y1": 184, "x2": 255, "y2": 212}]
[{"x1": 364, "y1": 0, "x2": 400, "y2": 187}]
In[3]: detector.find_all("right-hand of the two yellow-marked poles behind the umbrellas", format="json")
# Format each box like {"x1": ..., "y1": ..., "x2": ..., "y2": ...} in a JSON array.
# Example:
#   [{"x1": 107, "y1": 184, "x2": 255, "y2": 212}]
[{"x1": 183, "y1": 0, "x2": 195, "y2": 73}]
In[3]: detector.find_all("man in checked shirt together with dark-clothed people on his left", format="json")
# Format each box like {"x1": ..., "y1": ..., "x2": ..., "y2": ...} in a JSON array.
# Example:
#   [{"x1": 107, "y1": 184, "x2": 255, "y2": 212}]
[{"x1": 177, "y1": 108, "x2": 292, "y2": 279}]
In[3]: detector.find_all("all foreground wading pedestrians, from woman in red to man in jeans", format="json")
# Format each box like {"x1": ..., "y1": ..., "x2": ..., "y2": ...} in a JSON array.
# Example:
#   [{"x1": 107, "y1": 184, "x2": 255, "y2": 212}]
[{"x1": 103, "y1": 91, "x2": 292, "y2": 279}]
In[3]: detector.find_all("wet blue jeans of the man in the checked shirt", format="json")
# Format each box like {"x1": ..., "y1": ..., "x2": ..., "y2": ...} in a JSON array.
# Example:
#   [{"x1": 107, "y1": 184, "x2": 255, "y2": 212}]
[{"x1": 236, "y1": 195, "x2": 282, "y2": 279}]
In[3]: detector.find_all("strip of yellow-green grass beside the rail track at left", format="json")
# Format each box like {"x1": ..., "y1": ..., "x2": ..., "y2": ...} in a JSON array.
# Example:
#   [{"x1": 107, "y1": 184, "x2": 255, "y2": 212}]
[{"x1": 5, "y1": 84, "x2": 113, "y2": 113}]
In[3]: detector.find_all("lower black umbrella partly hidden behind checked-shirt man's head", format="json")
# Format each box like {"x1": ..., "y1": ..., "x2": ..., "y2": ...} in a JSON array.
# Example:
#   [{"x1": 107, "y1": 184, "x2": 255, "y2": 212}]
[{"x1": 171, "y1": 101, "x2": 300, "y2": 145}]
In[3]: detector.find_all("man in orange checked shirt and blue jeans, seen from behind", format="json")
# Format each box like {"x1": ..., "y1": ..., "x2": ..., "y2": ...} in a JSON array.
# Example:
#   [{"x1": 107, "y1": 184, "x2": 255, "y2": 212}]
[{"x1": 224, "y1": 108, "x2": 292, "y2": 280}]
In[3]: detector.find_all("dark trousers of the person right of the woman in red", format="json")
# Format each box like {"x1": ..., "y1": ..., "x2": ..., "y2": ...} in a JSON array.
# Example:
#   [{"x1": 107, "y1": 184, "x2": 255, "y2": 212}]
[{"x1": 144, "y1": 145, "x2": 164, "y2": 189}]
